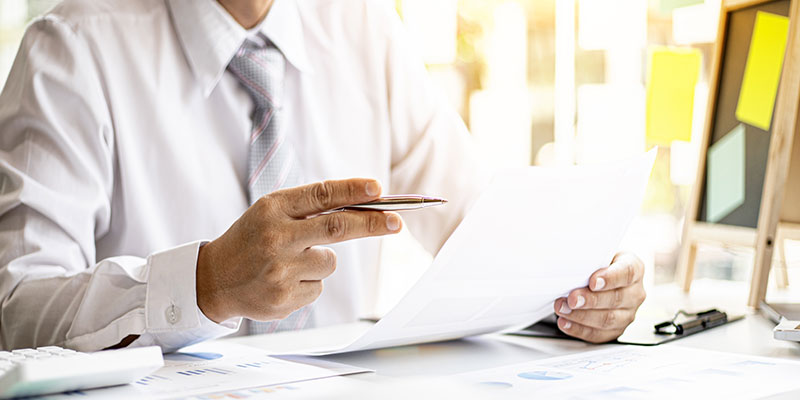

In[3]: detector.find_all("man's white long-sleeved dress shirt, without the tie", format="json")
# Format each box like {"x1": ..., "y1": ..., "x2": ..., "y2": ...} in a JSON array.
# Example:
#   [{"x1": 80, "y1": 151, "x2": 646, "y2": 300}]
[{"x1": 0, "y1": 0, "x2": 479, "y2": 351}]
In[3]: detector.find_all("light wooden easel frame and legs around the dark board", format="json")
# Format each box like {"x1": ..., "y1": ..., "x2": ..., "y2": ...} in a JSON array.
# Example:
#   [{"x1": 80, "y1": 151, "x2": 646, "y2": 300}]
[{"x1": 678, "y1": 0, "x2": 800, "y2": 308}]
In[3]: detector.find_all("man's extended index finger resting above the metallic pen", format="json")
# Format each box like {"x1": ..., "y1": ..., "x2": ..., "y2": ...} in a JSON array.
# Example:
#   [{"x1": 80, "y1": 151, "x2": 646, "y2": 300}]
[{"x1": 270, "y1": 178, "x2": 381, "y2": 218}]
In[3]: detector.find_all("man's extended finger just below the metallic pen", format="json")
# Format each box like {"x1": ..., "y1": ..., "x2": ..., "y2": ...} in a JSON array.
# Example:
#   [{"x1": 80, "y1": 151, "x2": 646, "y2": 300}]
[{"x1": 294, "y1": 211, "x2": 403, "y2": 246}]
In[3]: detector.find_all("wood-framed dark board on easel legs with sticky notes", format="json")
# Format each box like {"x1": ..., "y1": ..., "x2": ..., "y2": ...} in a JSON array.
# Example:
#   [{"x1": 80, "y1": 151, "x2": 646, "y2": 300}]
[{"x1": 677, "y1": 0, "x2": 800, "y2": 308}]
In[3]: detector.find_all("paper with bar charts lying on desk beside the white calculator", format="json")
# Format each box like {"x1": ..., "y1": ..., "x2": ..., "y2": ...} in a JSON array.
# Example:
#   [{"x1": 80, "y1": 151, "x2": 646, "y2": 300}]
[{"x1": 39, "y1": 341, "x2": 369, "y2": 399}]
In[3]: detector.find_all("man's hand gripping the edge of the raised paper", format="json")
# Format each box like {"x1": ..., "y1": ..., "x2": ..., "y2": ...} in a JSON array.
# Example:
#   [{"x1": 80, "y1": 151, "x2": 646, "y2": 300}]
[{"x1": 555, "y1": 254, "x2": 645, "y2": 343}]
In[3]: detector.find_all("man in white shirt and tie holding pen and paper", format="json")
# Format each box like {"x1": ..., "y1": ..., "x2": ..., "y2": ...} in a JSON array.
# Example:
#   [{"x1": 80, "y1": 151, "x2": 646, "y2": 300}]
[{"x1": 0, "y1": 0, "x2": 644, "y2": 351}]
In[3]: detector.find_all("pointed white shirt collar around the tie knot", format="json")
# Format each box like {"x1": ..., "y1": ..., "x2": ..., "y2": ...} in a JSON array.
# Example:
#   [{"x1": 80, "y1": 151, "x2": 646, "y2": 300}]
[{"x1": 167, "y1": 0, "x2": 312, "y2": 96}]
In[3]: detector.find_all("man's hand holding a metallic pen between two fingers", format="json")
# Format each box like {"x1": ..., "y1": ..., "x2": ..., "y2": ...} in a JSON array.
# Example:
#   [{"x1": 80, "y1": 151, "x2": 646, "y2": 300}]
[{"x1": 196, "y1": 179, "x2": 402, "y2": 323}]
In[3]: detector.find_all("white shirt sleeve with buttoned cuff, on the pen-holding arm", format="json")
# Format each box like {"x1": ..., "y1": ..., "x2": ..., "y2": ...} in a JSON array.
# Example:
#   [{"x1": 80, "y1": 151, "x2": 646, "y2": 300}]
[{"x1": 0, "y1": 16, "x2": 239, "y2": 351}]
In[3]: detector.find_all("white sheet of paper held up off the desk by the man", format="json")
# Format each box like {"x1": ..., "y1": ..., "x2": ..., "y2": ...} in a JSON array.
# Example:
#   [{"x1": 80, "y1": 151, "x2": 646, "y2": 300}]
[{"x1": 304, "y1": 149, "x2": 656, "y2": 354}]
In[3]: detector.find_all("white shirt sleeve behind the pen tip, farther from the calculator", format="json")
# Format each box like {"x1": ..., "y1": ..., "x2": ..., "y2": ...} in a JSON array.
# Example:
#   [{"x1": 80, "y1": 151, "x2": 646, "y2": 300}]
[{"x1": 378, "y1": 7, "x2": 488, "y2": 254}]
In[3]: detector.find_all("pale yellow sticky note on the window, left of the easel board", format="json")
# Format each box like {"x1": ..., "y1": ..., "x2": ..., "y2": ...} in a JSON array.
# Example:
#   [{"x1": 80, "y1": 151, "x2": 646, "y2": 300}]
[{"x1": 647, "y1": 47, "x2": 701, "y2": 146}]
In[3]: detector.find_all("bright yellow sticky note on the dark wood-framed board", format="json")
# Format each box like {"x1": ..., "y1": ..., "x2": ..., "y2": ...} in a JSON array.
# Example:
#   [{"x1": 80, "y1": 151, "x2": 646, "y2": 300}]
[{"x1": 736, "y1": 11, "x2": 789, "y2": 131}]
